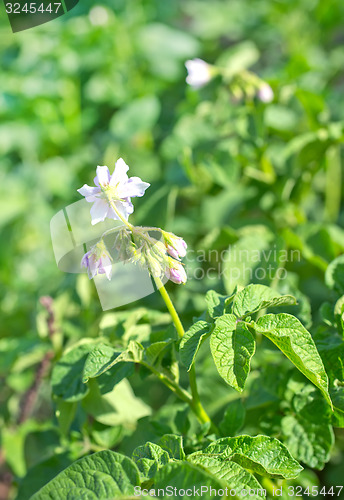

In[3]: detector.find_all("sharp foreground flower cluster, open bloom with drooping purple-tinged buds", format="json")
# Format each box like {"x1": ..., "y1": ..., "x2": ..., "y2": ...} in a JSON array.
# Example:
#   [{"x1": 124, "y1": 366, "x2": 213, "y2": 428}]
[{"x1": 78, "y1": 158, "x2": 187, "y2": 284}]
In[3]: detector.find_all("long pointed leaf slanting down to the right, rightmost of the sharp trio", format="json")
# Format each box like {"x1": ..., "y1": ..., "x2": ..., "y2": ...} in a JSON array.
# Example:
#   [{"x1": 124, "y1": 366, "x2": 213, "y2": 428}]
[{"x1": 255, "y1": 313, "x2": 332, "y2": 407}]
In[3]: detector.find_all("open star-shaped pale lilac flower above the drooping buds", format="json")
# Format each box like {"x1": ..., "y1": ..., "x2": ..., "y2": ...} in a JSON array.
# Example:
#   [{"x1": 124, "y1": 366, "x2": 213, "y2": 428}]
[{"x1": 78, "y1": 158, "x2": 150, "y2": 225}]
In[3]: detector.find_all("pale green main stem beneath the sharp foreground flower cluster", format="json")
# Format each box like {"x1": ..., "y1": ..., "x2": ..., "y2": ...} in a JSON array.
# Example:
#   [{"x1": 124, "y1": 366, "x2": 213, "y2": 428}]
[{"x1": 154, "y1": 278, "x2": 216, "y2": 432}]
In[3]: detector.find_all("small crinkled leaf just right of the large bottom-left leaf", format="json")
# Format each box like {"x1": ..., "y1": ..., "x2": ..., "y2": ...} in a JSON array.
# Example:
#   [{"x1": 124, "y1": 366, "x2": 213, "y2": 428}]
[{"x1": 132, "y1": 442, "x2": 170, "y2": 481}]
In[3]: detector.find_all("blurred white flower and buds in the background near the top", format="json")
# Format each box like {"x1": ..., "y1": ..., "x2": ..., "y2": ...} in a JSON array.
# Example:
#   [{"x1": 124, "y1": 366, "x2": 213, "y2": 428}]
[{"x1": 185, "y1": 59, "x2": 274, "y2": 103}]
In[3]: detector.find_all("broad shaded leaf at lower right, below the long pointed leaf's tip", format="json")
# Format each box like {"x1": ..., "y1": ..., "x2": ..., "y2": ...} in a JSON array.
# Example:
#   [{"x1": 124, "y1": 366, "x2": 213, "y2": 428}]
[{"x1": 281, "y1": 413, "x2": 334, "y2": 469}]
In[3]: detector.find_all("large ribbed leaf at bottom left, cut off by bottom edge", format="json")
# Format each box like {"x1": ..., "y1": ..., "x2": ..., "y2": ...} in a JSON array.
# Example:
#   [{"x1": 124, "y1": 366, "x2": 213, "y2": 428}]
[{"x1": 31, "y1": 451, "x2": 140, "y2": 500}]
